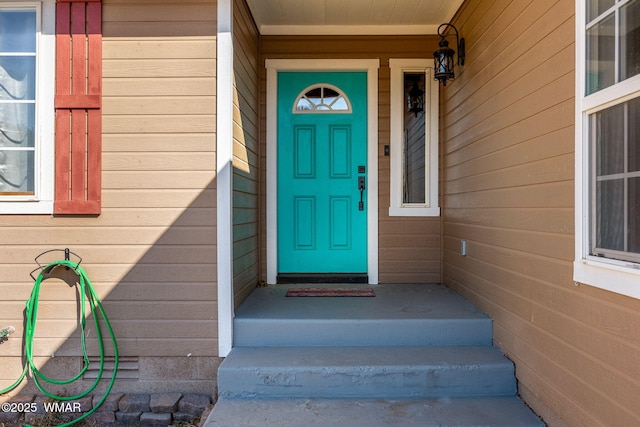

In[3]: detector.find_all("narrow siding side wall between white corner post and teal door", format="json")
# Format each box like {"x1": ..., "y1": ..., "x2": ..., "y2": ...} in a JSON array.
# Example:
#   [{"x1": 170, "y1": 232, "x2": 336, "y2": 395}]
[{"x1": 233, "y1": 0, "x2": 260, "y2": 307}]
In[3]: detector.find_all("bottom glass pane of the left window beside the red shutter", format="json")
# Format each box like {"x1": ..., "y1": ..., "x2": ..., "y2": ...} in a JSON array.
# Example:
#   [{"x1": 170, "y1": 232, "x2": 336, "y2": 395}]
[{"x1": 0, "y1": 149, "x2": 35, "y2": 194}]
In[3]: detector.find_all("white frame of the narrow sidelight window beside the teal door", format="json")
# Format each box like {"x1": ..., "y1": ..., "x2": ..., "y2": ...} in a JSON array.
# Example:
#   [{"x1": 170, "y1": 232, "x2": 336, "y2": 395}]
[{"x1": 389, "y1": 58, "x2": 440, "y2": 217}]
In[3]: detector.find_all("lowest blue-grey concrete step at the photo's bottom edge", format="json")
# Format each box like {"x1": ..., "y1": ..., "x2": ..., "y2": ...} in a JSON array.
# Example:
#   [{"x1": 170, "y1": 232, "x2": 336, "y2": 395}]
[{"x1": 204, "y1": 397, "x2": 545, "y2": 427}]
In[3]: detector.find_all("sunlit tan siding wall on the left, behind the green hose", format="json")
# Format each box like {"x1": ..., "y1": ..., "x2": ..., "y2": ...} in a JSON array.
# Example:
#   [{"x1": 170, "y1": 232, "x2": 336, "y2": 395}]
[{"x1": 0, "y1": 0, "x2": 217, "y2": 394}]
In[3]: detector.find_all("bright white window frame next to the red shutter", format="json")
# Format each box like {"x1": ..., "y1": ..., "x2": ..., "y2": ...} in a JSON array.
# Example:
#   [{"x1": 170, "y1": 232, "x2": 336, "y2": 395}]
[{"x1": 0, "y1": 0, "x2": 56, "y2": 214}]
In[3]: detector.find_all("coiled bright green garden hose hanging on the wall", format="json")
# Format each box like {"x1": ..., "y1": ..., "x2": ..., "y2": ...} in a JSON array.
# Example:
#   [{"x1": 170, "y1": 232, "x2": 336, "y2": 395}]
[{"x1": 0, "y1": 260, "x2": 118, "y2": 427}]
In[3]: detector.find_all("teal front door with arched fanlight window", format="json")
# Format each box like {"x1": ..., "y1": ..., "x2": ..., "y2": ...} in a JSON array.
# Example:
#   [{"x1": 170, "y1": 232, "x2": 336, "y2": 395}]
[{"x1": 277, "y1": 72, "x2": 367, "y2": 273}]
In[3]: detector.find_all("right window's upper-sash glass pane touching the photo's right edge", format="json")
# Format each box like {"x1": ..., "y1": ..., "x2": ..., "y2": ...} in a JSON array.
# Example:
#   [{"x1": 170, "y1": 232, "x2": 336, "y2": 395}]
[{"x1": 620, "y1": 0, "x2": 640, "y2": 80}]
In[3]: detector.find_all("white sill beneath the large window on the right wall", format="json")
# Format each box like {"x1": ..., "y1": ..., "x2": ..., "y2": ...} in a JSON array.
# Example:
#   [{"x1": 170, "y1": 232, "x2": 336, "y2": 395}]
[{"x1": 573, "y1": 258, "x2": 640, "y2": 299}]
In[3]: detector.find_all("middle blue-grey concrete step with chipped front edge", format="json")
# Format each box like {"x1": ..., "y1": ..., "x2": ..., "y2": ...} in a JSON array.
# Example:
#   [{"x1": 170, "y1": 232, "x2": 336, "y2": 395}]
[{"x1": 218, "y1": 346, "x2": 516, "y2": 399}]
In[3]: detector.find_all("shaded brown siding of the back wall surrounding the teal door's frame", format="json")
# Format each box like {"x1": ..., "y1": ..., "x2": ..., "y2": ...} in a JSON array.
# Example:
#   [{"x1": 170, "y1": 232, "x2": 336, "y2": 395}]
[{"x1": 261, "y1": 36, "x2": 441, "y2": 283}]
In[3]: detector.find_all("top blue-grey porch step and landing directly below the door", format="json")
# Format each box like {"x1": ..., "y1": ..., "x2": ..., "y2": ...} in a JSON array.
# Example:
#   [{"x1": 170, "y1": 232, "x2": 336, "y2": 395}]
[{"x1": 234, "y1": 285, "x2": 492, "y2": 347}]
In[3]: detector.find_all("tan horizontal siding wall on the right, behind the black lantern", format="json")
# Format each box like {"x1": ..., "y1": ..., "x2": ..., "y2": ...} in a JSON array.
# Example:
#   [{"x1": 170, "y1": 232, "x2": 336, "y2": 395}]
[{"x1": 441, "y1": 0, "x2": 640, "y2": 426}]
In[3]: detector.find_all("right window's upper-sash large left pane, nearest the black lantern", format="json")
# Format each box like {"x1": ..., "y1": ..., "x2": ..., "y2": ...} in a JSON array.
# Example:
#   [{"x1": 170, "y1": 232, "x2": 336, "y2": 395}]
[{"x1": 585, "y1": 14, "x2": 616, "y2": 95}]
